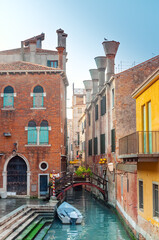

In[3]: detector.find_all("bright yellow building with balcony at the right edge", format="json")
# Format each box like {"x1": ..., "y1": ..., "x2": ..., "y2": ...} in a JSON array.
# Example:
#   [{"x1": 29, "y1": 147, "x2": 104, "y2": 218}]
[{"x1": 132, "y1": 69, "x2": 159, "y2": 239}]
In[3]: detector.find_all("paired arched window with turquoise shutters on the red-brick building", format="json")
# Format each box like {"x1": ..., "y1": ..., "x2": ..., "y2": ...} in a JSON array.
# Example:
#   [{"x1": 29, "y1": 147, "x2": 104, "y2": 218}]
[{"x1": 26, "y1": 120, "x2": 51, "y2": 145}]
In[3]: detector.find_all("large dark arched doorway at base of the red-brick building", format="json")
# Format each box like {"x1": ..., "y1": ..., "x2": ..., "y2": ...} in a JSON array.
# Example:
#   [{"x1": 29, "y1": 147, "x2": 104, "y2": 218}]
[{"x1": 7, "y1": 156, "x2": 27, "y2": 195}]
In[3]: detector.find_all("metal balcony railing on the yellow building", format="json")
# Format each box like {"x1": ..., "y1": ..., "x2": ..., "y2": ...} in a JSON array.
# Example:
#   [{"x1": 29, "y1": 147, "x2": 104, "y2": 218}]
[{"x1": 119, "y1": 131, "x2": 159, "y2": 155}]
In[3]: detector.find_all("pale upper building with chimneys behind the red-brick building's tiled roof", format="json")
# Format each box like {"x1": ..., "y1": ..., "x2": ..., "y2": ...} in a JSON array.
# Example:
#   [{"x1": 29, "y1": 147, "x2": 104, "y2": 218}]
[{"x1": 0, "y1": 29, "x2": 67, "y2": 71}]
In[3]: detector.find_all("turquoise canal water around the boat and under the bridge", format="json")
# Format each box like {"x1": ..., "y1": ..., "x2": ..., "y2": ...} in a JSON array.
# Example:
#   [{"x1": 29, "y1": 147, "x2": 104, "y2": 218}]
[{"x1": 44, "y1": 189, "x2": 130, "y2": 240}]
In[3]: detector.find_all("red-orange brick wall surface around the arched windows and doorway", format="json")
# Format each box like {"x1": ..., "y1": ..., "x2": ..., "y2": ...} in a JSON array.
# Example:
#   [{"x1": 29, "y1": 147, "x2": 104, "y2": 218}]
[{"x1": 0, "y1": 73, "x2": 66, "y2": 195}]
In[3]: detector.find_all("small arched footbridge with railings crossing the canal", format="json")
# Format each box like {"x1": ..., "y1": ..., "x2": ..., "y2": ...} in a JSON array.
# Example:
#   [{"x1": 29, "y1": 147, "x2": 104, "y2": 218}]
[{"x1": 55, "y1": 173, "x2": 108, "y2": 201}]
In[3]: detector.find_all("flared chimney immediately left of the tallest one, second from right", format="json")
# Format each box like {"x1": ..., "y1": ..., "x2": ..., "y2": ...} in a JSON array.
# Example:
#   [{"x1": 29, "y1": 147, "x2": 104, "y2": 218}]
[{"x1": 94, "y1": 56, "x2": 107, "y2": 91}]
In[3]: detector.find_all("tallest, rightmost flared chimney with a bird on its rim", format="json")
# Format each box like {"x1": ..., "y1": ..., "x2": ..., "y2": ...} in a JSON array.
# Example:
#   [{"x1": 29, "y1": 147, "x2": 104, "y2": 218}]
[{"x1": 102, "y1": 41, "x2": 120, "y2": 82}]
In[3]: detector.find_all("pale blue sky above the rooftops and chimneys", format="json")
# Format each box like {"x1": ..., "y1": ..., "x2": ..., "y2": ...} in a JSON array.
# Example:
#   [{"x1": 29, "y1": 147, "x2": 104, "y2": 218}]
[{"x1": 0, "y1": 0, "x2": 159, "y2": 116}]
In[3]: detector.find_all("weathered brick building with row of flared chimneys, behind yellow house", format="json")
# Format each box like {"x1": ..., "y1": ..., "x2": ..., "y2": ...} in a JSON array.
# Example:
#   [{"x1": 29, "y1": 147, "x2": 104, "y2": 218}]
[{"x1": 84, "y1": 41, "x2": 159, "y2": 234}]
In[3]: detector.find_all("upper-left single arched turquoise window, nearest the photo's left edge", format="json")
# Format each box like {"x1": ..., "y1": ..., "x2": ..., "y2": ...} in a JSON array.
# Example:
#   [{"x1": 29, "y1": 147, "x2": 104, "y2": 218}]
[{"x1": 3, "y1": 86, "x2": 14, "y2": 108}]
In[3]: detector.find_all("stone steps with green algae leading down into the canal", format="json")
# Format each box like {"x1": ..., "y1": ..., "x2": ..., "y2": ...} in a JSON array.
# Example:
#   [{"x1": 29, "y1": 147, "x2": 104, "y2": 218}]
[{"x1": 0, "y1": 205, "x2": 56, "y2": 240}]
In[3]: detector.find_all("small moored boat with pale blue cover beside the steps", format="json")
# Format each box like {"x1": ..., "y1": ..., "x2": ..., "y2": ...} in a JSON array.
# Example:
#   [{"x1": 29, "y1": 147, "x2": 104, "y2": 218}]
[{"x1": 57, "y1": 202, "x2": 83, "y2": 224}]
